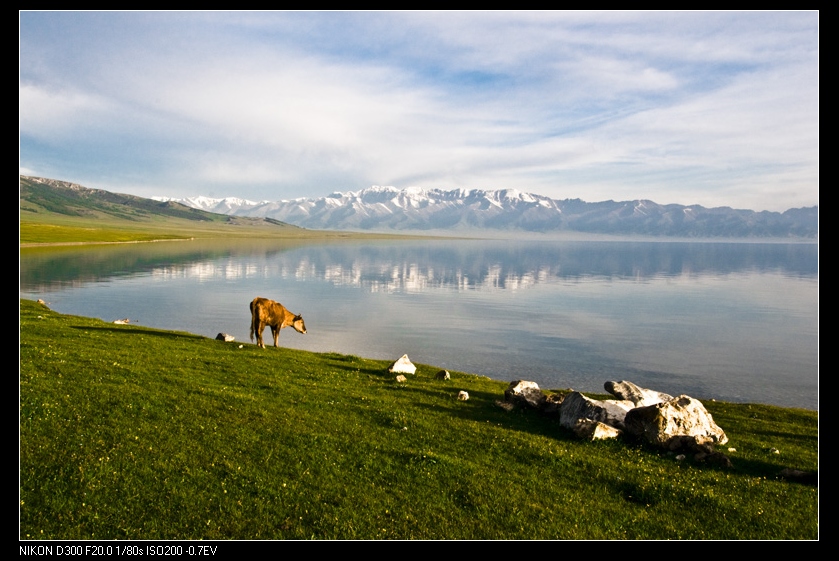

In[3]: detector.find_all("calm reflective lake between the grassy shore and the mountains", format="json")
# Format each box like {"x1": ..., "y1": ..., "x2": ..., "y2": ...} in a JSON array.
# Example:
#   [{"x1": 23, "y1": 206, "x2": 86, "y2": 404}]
[{"x1": 20, "y1": 236, "x2": 819, "y2": 410}]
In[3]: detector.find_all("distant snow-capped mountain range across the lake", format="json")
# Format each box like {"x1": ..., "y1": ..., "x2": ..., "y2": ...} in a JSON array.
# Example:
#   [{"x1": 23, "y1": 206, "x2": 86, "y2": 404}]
[{"x1": 155, "y1": 186, "x2": 818, "y2": 238}]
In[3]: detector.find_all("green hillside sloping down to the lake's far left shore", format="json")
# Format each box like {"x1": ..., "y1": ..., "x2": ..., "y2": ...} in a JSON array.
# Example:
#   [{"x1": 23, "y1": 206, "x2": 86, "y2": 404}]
[{"x1": 20, "y1": 176, "x2": 406, "y2": 245}]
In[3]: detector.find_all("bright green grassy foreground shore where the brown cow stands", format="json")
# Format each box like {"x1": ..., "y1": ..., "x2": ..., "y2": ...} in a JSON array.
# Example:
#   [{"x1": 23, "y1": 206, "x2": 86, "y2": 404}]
[{"x1": 20, "y1": 300, "x2": 819, "y2": 539}]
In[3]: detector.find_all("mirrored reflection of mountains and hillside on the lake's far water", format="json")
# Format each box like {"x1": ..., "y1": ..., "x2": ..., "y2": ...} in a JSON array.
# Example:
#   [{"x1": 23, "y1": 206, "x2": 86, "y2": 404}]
[{"x1": 21, "y1": 240, "x2": 818, "y2": 291}]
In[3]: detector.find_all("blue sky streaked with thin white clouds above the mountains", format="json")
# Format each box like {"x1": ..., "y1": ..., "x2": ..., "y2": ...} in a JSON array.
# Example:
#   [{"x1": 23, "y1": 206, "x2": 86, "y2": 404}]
[{"x1": 19, "y1": 11, "x2": 819, "y2": 211}]
